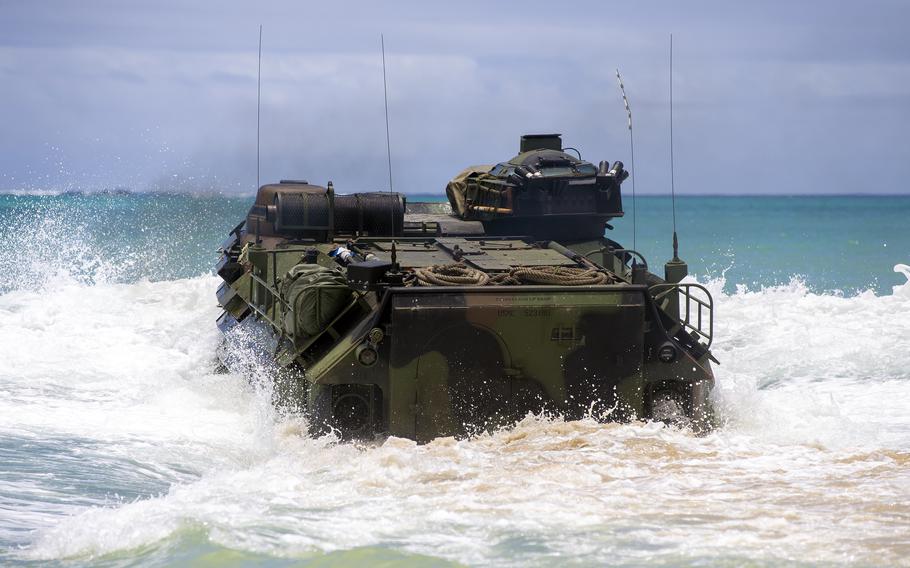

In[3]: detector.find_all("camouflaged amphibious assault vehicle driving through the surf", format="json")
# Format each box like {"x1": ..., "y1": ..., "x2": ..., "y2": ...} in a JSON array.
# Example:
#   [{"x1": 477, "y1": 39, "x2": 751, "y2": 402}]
[{"x1": 217, "y1": 134, "x2": 714, "y2": 442}]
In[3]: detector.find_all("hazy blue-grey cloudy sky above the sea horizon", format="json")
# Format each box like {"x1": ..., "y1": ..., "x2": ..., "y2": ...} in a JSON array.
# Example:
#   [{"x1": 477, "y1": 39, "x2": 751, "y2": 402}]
[{"x1": 0, "y1": 0, "x2": 910, "y2": 195}]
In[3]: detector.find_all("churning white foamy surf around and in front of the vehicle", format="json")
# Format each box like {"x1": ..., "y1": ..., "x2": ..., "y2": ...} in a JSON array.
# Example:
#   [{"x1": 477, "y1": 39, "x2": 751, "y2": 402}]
[{"x1": 0, "y1": 209, "x2": 910, "y2": 565}]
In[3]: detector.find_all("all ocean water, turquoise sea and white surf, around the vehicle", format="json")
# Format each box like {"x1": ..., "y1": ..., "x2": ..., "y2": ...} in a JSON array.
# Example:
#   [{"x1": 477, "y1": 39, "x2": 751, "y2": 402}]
[{"x1": 0, "y1": 194, "x2": 910, "y2": 566}]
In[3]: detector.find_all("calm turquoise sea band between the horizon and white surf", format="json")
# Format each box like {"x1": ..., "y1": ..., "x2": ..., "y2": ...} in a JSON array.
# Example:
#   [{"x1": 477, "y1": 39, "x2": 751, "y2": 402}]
[{"x1": 0, "y1": 193, "x2": 910, "y2": 295}]
